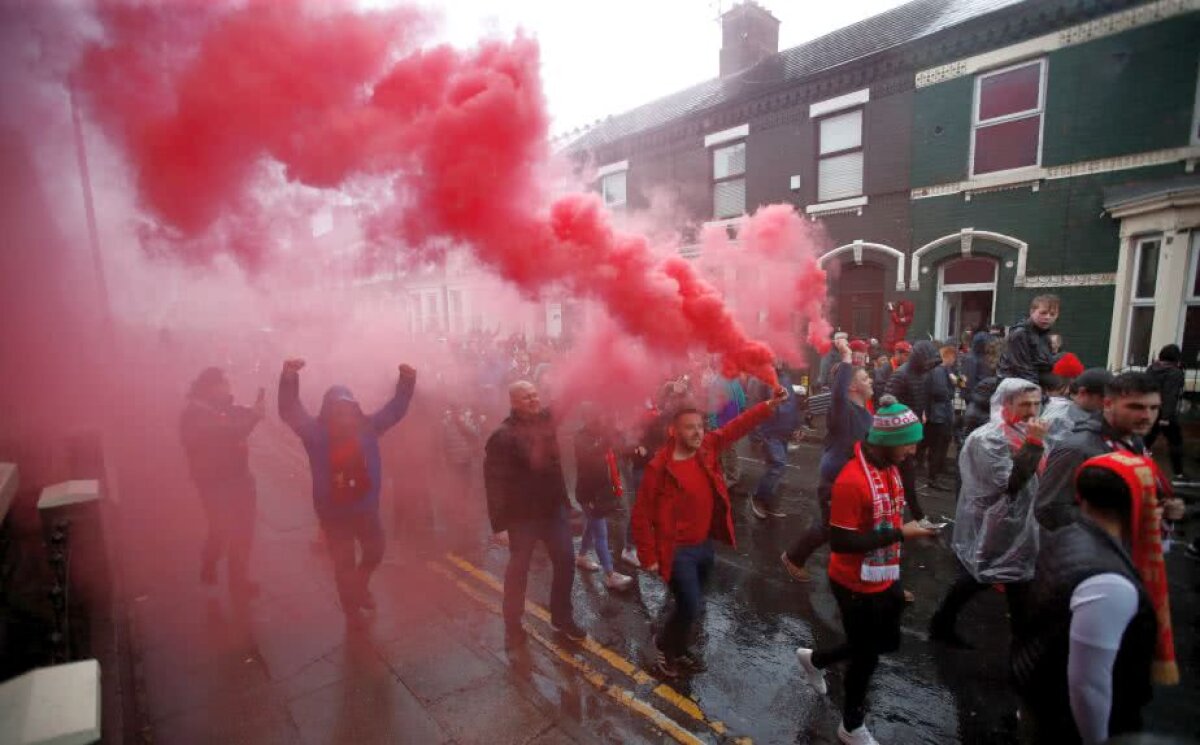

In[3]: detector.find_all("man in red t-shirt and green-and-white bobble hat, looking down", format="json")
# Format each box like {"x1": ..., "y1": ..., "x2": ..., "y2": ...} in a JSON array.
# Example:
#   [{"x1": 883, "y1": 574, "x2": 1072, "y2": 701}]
[{"x1": 796, "y1": 396, "x2": 936, "y2": 745}]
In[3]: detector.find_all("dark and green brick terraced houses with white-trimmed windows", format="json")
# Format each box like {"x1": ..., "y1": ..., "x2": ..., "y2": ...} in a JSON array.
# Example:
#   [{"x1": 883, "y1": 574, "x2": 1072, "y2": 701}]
[{"x1": 565, "y1": 0, "x2": 1200, "y2": 367}]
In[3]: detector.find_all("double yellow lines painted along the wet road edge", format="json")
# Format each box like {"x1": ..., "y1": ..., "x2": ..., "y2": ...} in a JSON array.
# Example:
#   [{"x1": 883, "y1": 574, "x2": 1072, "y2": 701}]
[{"x1": 430, "y1": 553, "x2": 751, "y2": 745}]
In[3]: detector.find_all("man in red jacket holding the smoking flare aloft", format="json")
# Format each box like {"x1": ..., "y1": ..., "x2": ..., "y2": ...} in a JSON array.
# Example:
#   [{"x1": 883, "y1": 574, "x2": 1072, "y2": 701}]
[{"x1": 632, "y1": 387, "x2": 787, "y2": 678}]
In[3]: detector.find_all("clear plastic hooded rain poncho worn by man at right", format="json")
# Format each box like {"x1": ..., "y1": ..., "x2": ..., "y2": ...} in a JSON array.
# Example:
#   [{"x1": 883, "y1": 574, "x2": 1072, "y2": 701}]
[{"x1": 950, "y1": 378, "x2": 1040, "y2": 583}]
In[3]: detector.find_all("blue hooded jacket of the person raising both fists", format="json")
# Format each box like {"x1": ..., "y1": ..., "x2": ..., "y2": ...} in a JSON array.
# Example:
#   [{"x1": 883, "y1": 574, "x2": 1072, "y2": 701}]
[{"x1": 280, "y1": 372, "x2": 415, "y2": 521}]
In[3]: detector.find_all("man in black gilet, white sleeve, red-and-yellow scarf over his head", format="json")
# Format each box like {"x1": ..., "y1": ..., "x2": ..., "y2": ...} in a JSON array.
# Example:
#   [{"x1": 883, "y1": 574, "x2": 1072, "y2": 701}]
[{"x1": 1012, "y1": 452, "x2": 1180, "y2": 745}]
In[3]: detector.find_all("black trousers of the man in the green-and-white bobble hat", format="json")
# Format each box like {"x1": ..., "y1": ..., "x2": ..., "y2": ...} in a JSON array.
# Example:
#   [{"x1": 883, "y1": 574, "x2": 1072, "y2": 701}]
[{"x1": 812, "y1": 582, "x2": 905, "y2": 731}]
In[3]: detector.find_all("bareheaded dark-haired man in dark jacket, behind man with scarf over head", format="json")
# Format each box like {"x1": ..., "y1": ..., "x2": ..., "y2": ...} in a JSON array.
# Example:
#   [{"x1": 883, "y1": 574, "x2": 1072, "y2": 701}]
[{"x1": 1036, "y1": 372, "x2": 1182, "y2": 530}]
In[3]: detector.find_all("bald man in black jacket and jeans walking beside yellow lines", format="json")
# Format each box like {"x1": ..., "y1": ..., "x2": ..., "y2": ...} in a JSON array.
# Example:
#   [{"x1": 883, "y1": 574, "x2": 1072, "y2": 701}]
[{"x1": 484, "y1": 380, "x2": 587, "y2": 645}]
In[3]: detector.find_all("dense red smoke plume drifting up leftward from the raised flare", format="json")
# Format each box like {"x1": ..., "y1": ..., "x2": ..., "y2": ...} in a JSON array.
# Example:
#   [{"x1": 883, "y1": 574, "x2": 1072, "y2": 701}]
[{"x1": 76, "y1": 0, "x2": 824, "y2": 380}]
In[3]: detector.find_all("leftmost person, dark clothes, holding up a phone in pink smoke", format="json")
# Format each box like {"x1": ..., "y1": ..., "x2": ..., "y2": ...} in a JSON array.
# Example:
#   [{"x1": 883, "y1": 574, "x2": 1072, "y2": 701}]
[{"x1": 179, "y1": 367, "x2": 266, "y2": 597}]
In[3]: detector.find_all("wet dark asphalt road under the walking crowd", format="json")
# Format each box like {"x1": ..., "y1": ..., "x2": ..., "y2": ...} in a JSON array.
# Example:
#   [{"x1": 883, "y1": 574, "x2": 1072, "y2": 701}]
[{"x1": 451, "y1": 443, "x2": 1200, "y2": 744}]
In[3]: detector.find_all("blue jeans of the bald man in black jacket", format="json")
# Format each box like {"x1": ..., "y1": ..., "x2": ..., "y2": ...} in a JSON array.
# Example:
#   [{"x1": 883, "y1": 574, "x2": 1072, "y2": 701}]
[{"x1": 504, "y1": 507, "x2": 575, "y2": 626}]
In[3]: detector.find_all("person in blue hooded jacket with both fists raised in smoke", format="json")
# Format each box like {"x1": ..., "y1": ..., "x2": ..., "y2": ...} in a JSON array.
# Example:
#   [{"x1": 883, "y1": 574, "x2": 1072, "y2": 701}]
[{"x1": 278, "y1": 359, "x2": 416, "y2": 618}]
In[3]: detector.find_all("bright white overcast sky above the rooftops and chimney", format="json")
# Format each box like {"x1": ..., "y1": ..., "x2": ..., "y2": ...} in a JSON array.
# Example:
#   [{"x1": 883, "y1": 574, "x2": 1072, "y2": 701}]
[{"x1": 417, "y1": 0, "x2": 902, "y2": 134}]
